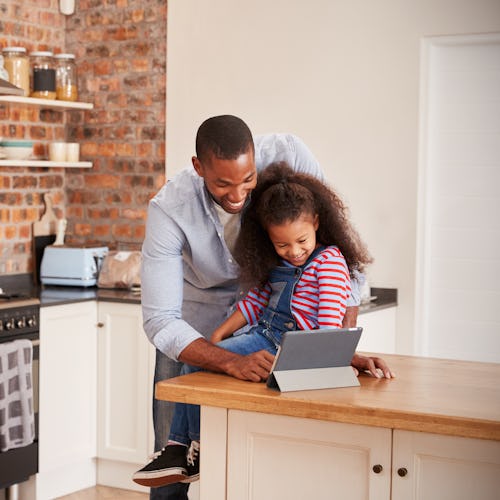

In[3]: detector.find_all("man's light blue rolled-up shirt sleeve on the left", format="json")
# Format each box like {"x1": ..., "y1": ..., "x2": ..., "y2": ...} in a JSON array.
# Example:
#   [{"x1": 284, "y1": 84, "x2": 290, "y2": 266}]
[{"x1": 141, "y1": 199, "x2": 202, "y2": 360}]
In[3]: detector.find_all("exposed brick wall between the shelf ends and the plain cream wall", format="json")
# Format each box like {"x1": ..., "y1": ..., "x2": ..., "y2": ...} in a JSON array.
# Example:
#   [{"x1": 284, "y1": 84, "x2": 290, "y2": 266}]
[{"x1": 66, "y1": 0, "x2": 167, "y2": 249}]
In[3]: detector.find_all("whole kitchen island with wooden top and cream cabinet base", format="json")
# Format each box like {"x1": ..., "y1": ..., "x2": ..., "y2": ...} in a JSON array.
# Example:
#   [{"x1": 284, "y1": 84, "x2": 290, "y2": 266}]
[{"x1": 156, "y1": 355, "x2": 500, "y2": 500}]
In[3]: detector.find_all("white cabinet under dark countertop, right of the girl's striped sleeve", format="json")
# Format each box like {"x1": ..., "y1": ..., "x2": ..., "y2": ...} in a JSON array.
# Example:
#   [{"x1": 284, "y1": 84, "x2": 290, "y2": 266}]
[{"x1": 357, "y1": 307, "x2": 396, "y2": 354}]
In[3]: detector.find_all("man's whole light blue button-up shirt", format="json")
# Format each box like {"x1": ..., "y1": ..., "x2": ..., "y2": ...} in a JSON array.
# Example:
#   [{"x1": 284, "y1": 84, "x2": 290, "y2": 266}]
[{"x1": 141, "y1": 134, "x2": 359, "y2": 359}]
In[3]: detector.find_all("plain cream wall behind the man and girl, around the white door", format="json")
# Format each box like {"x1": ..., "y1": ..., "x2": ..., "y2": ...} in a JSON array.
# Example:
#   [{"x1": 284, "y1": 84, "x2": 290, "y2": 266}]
[{"x1": 167, "y1": 0, "x2": 500, "y2": 353}]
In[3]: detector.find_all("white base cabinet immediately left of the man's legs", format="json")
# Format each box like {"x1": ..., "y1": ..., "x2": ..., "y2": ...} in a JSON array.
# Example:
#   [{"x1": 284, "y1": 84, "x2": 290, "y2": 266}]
[{"x1": 97, "y1": 302, "x2": 155, "y2": 491}]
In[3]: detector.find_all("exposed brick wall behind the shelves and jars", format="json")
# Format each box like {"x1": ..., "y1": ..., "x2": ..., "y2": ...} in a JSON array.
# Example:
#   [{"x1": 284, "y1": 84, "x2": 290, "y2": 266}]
[{"x1": 0, "y1": 0, "x2": 65, "y2": 274}]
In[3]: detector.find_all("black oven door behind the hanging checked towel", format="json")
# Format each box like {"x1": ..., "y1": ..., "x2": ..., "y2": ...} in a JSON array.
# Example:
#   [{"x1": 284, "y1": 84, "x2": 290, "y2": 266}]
[{"x1": 0, "y1": 333, "x2": 40, "y2": 490}]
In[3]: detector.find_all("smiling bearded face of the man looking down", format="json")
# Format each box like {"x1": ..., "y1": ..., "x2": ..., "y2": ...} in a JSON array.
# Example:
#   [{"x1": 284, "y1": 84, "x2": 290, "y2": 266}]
[{"x1": 192, "y1": 150, "x2": 257, "y2": 214}]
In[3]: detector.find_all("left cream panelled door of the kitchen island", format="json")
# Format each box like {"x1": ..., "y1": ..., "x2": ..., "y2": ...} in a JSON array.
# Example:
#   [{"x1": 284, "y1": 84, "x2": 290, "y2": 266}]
[{"x1": 227, "y1": 410, "x2": 391, "y2": 500}]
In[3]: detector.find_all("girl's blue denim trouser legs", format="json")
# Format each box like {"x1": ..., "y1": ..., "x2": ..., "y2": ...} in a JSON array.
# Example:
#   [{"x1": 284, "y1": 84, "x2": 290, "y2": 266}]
[{"x1": 169, "y1": 325, "x2": 279, "y2": 446}]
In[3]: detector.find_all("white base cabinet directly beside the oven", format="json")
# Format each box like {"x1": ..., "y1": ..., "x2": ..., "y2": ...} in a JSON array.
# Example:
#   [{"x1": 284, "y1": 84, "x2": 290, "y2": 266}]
[{"x1": 36, "y1": 301, "x2": 97, "y2": 500}]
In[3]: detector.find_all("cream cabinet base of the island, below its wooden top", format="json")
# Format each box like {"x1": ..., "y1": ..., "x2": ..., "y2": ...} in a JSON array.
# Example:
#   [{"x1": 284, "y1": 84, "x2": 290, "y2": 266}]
[{"x1": 204, "y1": 406, "x2": 500, "y2": 500}]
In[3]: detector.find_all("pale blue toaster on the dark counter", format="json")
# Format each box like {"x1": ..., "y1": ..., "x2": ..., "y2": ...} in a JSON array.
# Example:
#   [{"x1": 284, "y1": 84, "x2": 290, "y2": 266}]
[{"x1": 40, "y1": 245, "x2": 109, "y2": 286}]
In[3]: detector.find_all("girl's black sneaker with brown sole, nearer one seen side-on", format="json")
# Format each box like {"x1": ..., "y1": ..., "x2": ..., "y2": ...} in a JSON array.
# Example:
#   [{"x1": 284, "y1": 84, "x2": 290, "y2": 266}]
[{"x1": 132, "y1": 444, "x2": 188, "y2": 488}]
